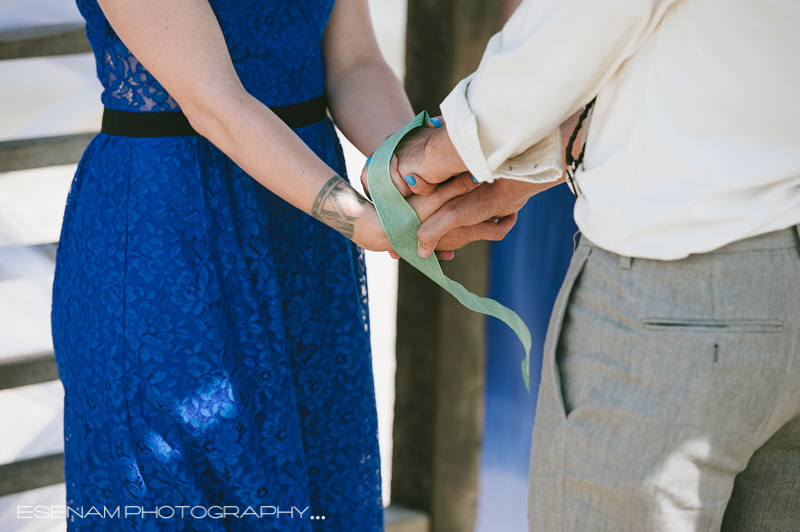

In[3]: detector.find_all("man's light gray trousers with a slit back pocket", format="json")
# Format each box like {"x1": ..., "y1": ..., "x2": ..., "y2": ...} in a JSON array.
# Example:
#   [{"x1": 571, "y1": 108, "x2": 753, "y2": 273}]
[{"x1": 528, "y1": 228, "x2": 800, "y2": 532}]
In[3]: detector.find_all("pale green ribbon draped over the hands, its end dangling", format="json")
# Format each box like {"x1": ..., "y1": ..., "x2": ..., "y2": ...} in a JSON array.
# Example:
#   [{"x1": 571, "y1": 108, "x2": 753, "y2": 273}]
[{"x1": 367, "y1": 111, "x2": 531, "y2": 391}]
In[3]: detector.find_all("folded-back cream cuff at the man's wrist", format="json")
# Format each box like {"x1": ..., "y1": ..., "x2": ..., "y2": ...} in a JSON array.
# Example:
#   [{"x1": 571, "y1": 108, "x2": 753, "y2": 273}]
[{"x1": 440, "y1": 74, "x2": 564, "y2": 183}]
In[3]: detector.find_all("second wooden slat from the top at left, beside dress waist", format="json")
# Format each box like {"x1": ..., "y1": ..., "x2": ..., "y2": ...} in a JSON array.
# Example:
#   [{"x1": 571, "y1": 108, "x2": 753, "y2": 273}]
[{"x1": 0, "y1": 133, "x2": 97, "y2": 172}]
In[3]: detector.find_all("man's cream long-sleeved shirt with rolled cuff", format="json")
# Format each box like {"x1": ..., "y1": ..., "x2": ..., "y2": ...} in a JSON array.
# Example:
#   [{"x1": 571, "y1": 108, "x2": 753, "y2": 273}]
[{"x1": 441, "y1": 0, "x2": 800, "y2": 260}]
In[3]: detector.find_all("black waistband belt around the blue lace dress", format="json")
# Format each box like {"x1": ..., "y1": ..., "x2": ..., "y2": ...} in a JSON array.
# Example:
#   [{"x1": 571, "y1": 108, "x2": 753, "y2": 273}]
[{"x1": 100, "y1": 94, "x2": 326, "y2": 137}]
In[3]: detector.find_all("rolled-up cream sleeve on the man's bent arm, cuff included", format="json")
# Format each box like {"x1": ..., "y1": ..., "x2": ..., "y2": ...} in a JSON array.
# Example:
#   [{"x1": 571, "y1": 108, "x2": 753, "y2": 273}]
[{"x1": 441, "y1": 0, "x2": 685, "y2": 182}]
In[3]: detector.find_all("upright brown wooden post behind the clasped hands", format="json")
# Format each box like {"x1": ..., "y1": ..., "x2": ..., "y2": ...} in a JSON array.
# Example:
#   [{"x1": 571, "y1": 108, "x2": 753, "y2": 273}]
[{"x1": 392, "y1": 0, "x2": 500, "y2": 532}]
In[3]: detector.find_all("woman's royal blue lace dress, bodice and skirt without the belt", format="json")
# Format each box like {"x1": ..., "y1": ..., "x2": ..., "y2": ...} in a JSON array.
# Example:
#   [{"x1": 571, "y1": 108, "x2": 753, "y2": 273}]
[{"x1": 52, "y1": 0, "x2": 383, "y2": 532}]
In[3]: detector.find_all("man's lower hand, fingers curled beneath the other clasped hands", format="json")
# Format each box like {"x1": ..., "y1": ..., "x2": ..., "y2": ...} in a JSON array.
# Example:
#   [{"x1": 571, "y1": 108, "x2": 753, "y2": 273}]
[{"x1": 417, "y1": 177, "x2": 564, "y2": 257}]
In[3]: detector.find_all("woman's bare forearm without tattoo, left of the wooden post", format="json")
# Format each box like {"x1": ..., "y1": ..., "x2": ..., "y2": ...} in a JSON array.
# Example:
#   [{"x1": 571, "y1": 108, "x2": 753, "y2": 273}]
[{"x1": 322, "y1": 0, "x2": 414, "y2": 155}]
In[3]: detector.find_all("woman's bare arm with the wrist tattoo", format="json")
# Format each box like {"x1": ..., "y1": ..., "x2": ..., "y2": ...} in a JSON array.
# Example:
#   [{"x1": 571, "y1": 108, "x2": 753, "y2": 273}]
[{"x1": 99, "y1": 0, "x2": 389, "y2": 251}]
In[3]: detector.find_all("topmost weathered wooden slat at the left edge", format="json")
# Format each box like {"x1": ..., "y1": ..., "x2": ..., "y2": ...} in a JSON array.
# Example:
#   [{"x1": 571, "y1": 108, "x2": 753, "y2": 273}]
[{"x1": 0, "y1": 23, "x2": 92, "y2": 60}]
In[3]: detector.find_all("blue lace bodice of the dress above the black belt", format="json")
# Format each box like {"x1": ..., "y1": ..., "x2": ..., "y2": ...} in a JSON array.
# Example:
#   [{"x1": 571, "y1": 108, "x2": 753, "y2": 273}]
[{"x1": 78, "y1": 0, "x2": 333, "y2": 112}]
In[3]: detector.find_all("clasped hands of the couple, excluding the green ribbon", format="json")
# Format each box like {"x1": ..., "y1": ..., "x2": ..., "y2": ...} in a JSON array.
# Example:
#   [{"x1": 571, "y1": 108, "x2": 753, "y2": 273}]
[{"x1": 361, "y1": 117, "x2": 549, "y2": 260}]
